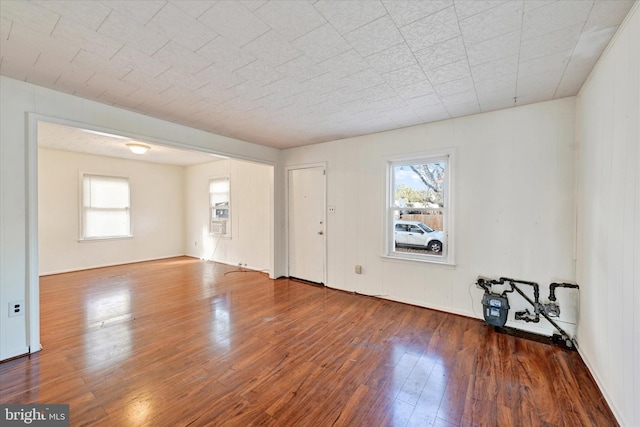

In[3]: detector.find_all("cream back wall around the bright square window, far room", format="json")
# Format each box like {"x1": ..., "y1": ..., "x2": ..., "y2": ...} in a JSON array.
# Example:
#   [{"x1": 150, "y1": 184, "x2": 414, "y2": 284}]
[{"x1": 38, "y1": 148, "x2": 184, "y2": 274}]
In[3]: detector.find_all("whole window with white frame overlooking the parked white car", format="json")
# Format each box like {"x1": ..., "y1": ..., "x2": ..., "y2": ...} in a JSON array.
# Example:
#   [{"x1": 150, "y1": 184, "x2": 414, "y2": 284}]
[{"x1": 386, "y1": 153, "x2": 453, "y2": 264}]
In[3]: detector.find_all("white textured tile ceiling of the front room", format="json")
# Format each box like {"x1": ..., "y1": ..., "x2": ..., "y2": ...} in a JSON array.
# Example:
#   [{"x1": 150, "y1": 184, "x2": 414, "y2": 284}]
[{"x1": 0, "y1": 0, "x2": 633, "y2": 148}]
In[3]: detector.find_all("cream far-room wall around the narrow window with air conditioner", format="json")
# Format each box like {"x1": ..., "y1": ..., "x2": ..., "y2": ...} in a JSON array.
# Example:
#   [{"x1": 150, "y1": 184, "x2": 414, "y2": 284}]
[{"x1": 184, "y1": 159, "x2": 273, "y2": 274}]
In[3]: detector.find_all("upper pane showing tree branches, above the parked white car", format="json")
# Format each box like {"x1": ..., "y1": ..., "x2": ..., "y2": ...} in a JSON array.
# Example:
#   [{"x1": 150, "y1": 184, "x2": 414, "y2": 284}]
[{"x1": 393, "y1": 161, "x2": 446, "y2": 213}]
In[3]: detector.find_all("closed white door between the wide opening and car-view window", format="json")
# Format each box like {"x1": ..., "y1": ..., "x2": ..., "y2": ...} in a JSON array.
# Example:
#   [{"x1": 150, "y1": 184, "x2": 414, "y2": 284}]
[{"x1": 288, "y1": 167, "x2": 326, "y2": 284}]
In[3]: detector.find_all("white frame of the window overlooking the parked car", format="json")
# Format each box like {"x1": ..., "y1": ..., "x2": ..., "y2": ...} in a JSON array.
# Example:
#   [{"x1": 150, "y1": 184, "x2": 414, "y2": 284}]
[{"x1": 383, "y1": 149, "x2": 455, "y2": 265}]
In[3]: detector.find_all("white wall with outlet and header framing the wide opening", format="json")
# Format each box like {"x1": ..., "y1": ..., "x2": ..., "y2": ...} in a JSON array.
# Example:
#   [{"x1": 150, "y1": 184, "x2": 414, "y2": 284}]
[{"x1": 0, "y1": 76, "x2": 279, "y2": 360}]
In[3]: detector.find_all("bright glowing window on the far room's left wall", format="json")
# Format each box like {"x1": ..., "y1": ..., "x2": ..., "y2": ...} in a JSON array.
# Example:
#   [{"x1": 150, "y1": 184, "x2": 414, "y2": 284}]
[{"x1": 80, "y1": 175, "x2": 131, "y2": 240}]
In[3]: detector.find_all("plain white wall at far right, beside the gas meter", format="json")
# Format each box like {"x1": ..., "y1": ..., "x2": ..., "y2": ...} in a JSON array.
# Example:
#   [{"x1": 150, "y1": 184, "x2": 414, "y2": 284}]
[{"x1": 576, "y1": 3, "x2": 640, "y2": 426}]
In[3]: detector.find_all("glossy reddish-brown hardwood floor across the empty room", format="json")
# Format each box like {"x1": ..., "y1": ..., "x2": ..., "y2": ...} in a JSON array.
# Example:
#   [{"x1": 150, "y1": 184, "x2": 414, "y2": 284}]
[{"x1": 0, "y1": 257, "x2": 617, "y2": 427}]
